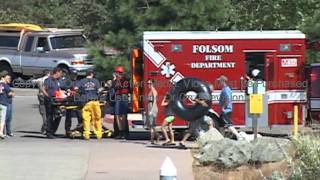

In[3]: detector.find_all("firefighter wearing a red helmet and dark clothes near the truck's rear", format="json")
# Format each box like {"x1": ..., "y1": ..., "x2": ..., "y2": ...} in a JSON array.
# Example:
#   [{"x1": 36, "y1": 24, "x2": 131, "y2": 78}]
[{"x1": 113, "y1": 66, "x2": 130, "y2": 139}]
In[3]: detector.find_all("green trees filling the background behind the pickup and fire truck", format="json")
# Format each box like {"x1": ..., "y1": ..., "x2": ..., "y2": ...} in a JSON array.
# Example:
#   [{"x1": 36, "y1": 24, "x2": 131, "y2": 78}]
[{"x1": 0, "y1": 0, "x2": 320, "y2": 76}]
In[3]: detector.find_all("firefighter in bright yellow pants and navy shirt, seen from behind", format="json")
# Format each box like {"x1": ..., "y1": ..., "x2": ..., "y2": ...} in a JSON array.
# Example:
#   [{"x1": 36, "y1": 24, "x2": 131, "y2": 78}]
[{"x1": 75, "y1": 70, "x2": 103, "y2": 140}]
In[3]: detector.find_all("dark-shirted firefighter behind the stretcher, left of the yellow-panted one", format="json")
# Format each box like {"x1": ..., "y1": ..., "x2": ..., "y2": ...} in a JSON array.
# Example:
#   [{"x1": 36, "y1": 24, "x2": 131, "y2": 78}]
[{"x1": 61, "y1": 70, "x2": 82, "y2": 137}]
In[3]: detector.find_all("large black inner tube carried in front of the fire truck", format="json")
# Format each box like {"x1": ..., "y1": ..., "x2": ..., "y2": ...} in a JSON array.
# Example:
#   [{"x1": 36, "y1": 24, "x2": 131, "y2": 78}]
[{"x1": 170, "y1": 78, "x2": 212, "y2": 121}]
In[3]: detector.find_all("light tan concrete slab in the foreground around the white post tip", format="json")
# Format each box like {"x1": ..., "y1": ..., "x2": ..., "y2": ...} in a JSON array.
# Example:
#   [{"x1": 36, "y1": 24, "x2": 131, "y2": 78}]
[{"x1": 86, "y1": 141, "x2": 194, "y2": 180}]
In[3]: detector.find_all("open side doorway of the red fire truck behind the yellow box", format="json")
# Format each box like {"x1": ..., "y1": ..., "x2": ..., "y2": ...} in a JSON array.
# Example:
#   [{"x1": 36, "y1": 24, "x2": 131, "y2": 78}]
[{"x1": 245, "y1": 52, "x2": 274, "y2": 127}]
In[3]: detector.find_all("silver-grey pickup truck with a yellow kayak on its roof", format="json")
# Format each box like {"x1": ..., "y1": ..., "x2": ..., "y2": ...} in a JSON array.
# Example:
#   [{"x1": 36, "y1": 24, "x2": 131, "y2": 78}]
[{"x1": 0, "y1": 25, "x2": 93, "y2": 77}]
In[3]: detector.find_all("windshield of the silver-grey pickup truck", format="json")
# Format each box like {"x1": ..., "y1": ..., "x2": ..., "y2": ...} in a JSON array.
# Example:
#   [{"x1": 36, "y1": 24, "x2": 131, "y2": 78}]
[{"x1": 50, "y1": 35, "x2": 86, "y2": 49}]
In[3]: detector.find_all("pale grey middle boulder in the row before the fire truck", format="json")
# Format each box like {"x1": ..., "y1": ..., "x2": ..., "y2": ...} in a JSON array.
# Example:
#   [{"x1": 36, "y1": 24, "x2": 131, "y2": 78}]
[{"x1": 217, "y1": 140, "x2": 252, "y2": 168}]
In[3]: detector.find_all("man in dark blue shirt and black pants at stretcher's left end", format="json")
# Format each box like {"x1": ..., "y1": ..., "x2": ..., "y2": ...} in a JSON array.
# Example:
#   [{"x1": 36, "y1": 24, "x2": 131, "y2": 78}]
[{"x1": 42, "y1": 68, "x2": 62, "y2": 139}]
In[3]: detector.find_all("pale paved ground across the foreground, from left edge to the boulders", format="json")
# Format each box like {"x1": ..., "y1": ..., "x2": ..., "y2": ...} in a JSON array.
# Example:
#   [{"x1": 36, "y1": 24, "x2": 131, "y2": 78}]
[{"x1": 0, "y1": 89, "x2": 193, "y2": 180}]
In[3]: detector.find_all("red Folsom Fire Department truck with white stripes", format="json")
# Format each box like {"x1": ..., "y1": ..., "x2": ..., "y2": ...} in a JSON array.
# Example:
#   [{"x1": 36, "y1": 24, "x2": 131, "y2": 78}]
[{"x1": 131, "y1": 30, "x2": 307, "y2": 129}]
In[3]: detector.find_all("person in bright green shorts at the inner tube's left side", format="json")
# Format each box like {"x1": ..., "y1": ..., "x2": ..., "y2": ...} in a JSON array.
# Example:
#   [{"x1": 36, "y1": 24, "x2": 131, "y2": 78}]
[{"x1": 161, "y1": 93, "x2": 175, "y2": 145}]
